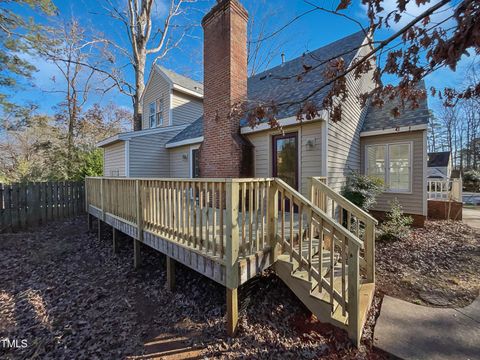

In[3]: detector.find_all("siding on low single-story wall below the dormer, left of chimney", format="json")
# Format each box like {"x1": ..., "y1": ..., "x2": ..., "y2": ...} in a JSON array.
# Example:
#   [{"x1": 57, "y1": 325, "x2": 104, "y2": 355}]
[{"x1": 129, "y1": 129, "x2": 185, "y2": 177}]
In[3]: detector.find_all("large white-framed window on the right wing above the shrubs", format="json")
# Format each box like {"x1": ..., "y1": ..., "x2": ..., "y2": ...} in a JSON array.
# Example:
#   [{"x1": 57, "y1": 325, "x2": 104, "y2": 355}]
[{"x1": 366, "y1": 143, "x2": 412, "y2": 192}]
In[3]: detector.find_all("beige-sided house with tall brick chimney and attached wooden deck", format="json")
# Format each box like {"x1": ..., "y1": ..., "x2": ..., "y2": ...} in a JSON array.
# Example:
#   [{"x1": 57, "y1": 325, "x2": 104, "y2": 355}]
[{"x1": 92, "y1": 0, "x2": 428, "y2": 345}]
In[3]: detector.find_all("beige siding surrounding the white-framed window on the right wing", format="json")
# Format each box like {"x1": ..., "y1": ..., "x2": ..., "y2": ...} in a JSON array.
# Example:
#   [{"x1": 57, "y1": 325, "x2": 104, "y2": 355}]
[{"x1": 361, "y1": 130, "x2": 427, "y2": 215}]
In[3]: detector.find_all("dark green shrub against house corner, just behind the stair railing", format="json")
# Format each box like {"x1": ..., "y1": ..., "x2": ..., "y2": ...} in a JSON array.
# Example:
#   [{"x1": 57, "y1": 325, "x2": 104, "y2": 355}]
[{"x1": 342, "y1": 172, "x2": 385, "y2": 211}]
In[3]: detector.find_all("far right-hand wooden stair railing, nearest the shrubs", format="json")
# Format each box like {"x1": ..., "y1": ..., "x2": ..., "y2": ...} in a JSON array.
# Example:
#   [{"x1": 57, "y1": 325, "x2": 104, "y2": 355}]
[{"x1": 310, "y1": 177, "x2": 378, "y2": 283}]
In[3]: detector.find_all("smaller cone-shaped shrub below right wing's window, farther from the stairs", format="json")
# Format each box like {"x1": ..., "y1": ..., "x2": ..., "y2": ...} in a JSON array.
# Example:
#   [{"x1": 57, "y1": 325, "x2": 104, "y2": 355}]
[{"x1": 379, "y1": 198, "x2": 413, "y2": 240}]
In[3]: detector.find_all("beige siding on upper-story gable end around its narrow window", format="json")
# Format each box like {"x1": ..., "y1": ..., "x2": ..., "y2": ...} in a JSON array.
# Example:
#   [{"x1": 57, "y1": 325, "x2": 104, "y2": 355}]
[{"x1": 142, "y1": 71, "x2": 171, "y2": 129}]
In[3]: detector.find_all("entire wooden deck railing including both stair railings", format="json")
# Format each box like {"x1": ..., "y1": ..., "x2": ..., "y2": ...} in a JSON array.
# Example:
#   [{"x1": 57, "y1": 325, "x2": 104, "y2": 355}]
[{"x1": 86, "y1": 178, "x2": 376, "y2": 344}]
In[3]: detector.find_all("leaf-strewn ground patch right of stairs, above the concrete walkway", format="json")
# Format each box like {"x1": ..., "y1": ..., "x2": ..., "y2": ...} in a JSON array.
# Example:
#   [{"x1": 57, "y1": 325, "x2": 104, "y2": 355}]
[{"x1": 376, "y1": 221, "x2": 480, "y2": 307}]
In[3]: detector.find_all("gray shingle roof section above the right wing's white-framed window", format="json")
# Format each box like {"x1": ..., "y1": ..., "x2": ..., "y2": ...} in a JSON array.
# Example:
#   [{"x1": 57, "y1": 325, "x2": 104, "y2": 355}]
[{"x1": 362, "y1": 81, "x2": 430, "y2": 131}]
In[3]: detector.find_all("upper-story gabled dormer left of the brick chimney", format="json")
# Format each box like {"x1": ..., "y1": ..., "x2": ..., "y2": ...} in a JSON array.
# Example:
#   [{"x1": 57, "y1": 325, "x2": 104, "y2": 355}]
[{"x1": 141, "y1": 65, "x2": 203, "y2": 130}]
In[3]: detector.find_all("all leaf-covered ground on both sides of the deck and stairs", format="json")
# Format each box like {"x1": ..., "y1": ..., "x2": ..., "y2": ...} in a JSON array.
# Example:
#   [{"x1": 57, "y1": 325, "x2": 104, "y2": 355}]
[{"x1": 0, "y1": 218, "x2": 479, "y2": 359}]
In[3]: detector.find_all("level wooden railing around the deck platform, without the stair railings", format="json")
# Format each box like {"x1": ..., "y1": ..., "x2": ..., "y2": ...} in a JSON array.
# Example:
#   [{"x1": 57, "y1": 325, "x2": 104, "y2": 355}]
[{"x1": 86, "y1": 178, "x2": 274, "y2": 284}]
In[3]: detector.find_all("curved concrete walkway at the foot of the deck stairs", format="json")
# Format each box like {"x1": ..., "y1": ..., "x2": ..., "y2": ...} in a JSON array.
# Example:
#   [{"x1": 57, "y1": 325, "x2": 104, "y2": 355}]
[{"x1": 374, "y1": 296, "x2": 480, "y2": 360}]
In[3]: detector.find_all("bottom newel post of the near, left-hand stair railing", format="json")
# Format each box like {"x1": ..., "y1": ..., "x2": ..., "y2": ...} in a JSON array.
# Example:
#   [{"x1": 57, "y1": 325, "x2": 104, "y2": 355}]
[{"x1": 348, "y1": 241, "x2": 362, "y2": 348}]
